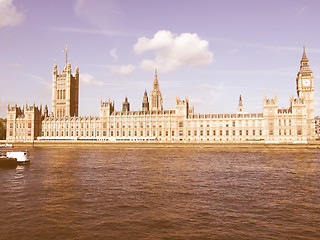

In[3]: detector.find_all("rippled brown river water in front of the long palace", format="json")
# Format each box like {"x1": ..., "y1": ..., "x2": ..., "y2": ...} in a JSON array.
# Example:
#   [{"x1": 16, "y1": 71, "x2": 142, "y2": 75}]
[{"x1": 0, "y1": 147, "x2": 320, "y2": 239}]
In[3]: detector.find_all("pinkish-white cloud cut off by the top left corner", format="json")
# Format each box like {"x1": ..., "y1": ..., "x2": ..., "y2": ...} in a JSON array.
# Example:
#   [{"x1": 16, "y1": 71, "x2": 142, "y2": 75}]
[{"x1": 0, "y1": 0, "x2": 24, "y2": 27}]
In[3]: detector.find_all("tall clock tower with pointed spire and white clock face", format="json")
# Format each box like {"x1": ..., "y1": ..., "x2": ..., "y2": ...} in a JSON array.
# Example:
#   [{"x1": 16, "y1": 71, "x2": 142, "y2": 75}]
[{"x1": 296, "y1": 47, "x2": 315, "y2": 139}]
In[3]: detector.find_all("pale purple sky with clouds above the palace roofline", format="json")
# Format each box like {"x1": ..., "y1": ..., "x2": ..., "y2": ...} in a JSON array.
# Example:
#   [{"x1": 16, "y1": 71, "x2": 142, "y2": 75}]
[{"x1": 0, "y1": 0, "x2": 320, "y2": 117}]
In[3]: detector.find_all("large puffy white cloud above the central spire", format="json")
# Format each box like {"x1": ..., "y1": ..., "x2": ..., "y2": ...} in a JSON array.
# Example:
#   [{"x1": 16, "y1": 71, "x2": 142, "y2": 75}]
[{"x1": 134, "y1": 30, "x2": 213, "y2": 72}]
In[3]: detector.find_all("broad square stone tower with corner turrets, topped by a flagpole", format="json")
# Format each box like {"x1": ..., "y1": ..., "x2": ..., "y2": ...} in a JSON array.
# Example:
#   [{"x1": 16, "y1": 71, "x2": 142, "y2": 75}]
[{"x1": 52, "y1": 60, "x2": 79, "y2": 117}]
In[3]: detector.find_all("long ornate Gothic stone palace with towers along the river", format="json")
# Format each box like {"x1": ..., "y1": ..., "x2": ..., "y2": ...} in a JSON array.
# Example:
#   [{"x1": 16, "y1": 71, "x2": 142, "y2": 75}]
[{"x1": 7, "y1": 48, "x2": 315, "y2": 143}]
